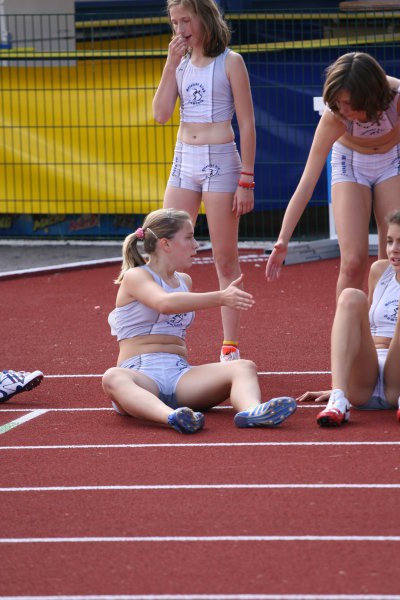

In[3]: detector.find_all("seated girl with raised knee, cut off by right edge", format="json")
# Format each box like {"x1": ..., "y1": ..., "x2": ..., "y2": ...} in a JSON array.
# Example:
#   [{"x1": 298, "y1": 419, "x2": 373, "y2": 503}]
[{"x1": 298, "y1": 210, "x2": 400, "y2": 426}]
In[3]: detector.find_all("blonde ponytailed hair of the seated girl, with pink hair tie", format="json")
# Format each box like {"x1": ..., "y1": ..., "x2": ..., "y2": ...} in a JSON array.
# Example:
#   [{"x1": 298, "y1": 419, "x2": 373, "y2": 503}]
[{"x1": 115, "y1": 208, "x2": 191, "y2": 283}]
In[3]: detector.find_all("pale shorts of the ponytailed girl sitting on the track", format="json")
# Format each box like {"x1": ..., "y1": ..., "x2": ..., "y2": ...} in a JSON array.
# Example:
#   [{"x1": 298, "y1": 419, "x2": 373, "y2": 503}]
[{"x1": 113, "y1": 352, "x2": 192, "y2": 412}]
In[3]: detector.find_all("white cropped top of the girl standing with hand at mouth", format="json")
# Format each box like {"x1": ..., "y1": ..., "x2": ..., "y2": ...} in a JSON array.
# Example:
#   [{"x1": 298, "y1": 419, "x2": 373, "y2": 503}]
[{"x1": 176, "y1": 48, "x2": 235, "y2": 123}]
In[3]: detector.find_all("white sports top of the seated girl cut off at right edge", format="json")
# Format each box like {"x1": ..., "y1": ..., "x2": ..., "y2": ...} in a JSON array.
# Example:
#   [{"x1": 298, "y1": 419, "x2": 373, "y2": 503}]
[{"x1": 369, "y1": 265, "x2": 400, "y2": 338}]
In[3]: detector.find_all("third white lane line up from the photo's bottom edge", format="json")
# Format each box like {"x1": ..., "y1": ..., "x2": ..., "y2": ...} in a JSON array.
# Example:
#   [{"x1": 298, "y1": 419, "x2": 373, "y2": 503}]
[{"x1": 0, "y1": 483, "x2": 400, "y2": 493}]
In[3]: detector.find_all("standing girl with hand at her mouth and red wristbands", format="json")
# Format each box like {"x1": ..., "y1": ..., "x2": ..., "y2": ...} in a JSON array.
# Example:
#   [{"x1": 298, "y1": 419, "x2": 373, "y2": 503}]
[{"x1": 153, "y1": 0, "x2": 256, "y2": 361}]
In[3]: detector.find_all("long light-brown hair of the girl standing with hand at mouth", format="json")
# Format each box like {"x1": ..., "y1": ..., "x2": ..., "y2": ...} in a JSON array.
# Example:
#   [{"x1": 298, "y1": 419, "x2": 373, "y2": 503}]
[{"x1": 167, "y1": 0, "x2": 231, "y2": 57}]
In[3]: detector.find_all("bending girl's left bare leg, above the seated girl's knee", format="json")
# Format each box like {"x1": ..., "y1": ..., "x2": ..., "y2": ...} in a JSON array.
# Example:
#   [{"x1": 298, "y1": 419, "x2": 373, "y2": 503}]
[{"x1": 332, "y1": 183, "x2": 372, "y2": 298}]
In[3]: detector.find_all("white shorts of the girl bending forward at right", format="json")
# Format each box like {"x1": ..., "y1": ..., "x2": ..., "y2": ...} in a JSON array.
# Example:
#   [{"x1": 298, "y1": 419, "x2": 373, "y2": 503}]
[{"x1": 331, "y1": 142, "x2": 400, "y2": 188}]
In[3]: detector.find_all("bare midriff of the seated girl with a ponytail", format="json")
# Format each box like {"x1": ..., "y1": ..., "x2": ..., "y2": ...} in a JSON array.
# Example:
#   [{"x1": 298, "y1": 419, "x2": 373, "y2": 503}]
[{"x1": 117, "y1": 335, "x2": 187, "y2": 365}]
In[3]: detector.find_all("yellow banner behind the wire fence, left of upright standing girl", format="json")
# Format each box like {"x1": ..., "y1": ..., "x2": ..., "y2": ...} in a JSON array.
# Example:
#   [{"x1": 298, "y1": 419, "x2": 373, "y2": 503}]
[{"x1": 0, "y1": 51, "x2": 178, "y2": 214}]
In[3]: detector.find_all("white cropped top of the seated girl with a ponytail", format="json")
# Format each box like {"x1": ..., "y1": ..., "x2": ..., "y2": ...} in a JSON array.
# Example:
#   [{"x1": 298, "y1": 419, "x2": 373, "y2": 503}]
[{"x1": 108, "y1": 265, "x2": 195, "y2": 341}]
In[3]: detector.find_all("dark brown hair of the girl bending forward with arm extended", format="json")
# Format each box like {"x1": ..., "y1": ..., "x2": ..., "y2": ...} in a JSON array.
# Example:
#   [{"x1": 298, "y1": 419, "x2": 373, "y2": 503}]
[{"x1": 323, "y1": 52, "x2": 396, "y2": 122}]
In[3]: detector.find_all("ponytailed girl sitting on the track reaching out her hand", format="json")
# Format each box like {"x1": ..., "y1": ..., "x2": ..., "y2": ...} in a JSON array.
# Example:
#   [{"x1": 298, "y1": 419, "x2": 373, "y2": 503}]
[{"x1": 102, "y1": 209, "x2": 296, "y2": 433}]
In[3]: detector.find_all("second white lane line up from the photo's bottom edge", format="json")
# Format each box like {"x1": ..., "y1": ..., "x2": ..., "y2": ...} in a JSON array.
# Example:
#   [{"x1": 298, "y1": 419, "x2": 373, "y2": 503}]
[{"x1": 0, "y1": 535, "x2": 400, "y2": 544}]
